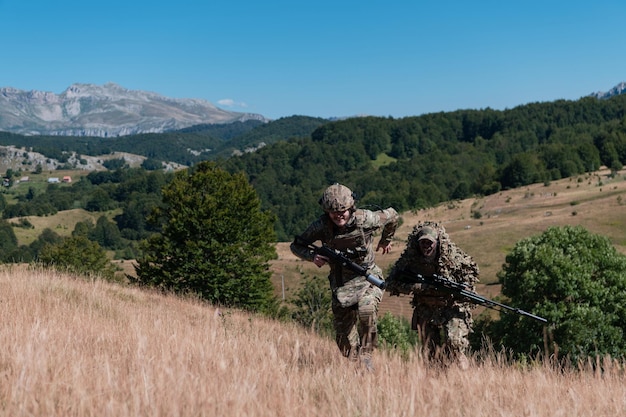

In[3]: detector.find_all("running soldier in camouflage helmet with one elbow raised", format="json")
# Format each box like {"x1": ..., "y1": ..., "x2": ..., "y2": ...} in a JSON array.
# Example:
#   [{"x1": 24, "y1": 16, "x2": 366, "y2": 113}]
[{"x1": 291, "y1": 184, "x2": 398, "y2": 370}]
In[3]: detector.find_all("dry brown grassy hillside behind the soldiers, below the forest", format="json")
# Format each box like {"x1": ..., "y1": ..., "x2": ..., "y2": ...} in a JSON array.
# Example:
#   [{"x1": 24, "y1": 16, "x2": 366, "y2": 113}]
[{"x1": 272, "y1": 170, "x2": 626, "y2": 318}]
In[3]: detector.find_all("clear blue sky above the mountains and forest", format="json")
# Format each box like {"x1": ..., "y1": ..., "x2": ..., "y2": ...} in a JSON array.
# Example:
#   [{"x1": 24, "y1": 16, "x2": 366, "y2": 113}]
[{"x1": 0, "y1": 0, "x2": 626, "y2": 119}]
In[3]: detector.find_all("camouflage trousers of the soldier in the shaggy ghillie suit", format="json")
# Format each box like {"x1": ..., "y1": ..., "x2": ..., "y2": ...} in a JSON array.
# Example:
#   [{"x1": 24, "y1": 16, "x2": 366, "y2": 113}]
[{"x1": 411, "y1": 301, "x2": 473, "y2": 360}]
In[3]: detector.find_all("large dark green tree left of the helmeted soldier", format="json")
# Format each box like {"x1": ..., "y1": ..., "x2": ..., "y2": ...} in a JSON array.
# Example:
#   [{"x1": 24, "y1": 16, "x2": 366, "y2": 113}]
[{"x1": 129, "y1": 162, "x2": 276, "y2": 312}]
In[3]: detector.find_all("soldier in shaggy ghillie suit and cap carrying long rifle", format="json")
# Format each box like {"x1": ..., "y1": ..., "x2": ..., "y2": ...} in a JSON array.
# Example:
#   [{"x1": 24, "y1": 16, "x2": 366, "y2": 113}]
[{"x1": 387, "y1": 222, "x2": 479, "y2": 367}]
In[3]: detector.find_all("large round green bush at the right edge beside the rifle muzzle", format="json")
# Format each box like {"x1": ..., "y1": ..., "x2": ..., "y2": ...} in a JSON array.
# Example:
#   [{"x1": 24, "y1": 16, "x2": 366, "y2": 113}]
[{"x1": 486, "y1": 226, "x2": 626, "y2": 361}]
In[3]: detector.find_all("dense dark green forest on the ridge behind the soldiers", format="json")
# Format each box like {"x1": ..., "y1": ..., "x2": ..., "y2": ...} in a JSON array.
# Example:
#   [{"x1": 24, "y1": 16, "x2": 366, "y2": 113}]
[{"x1": 216, "y1": 95, "x2": 626, "y2": 240}]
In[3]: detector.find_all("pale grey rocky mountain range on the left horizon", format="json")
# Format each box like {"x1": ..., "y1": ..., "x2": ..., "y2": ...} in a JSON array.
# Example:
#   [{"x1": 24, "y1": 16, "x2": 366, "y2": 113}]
[{"x1": 0, "y1": 83, "x2": 268, "y2": 137}]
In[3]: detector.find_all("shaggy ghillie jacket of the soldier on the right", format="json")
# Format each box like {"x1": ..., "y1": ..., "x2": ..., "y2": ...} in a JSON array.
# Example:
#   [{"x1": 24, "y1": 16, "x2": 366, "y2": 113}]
[{"x1": 387, "y1": 222, "x2": 479, "y2": 299}]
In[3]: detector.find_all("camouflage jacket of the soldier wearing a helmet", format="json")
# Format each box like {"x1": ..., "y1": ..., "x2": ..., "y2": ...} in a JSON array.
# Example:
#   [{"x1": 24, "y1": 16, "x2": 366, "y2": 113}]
[{"x1": 291, "y1": 207, "x2": 398, "y2": 288}]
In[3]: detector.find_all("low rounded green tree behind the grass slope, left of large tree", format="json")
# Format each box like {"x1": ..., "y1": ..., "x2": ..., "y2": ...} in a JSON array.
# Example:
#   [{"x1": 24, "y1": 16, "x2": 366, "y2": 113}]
[{"x1": 39, "y1": 235, "x2": 115, "y2": 280}]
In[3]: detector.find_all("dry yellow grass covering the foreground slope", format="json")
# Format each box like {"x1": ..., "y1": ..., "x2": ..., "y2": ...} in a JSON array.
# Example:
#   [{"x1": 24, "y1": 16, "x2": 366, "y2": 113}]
[{"x1": 0, "y1": 266, "x2": 626, "y2": 417}]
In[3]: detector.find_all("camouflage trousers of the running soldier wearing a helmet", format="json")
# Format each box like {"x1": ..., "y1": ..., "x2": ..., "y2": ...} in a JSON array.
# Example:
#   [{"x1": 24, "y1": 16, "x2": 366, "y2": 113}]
[{"x1": 332, "y1": 278, "x2": 383, "y2": 360}]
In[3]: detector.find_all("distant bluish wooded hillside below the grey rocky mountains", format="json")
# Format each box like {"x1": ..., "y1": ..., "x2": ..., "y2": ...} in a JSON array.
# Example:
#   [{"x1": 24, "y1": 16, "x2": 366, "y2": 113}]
[{"x1": 0, "y1": 116, "x2": 330, "y2": 168}]
